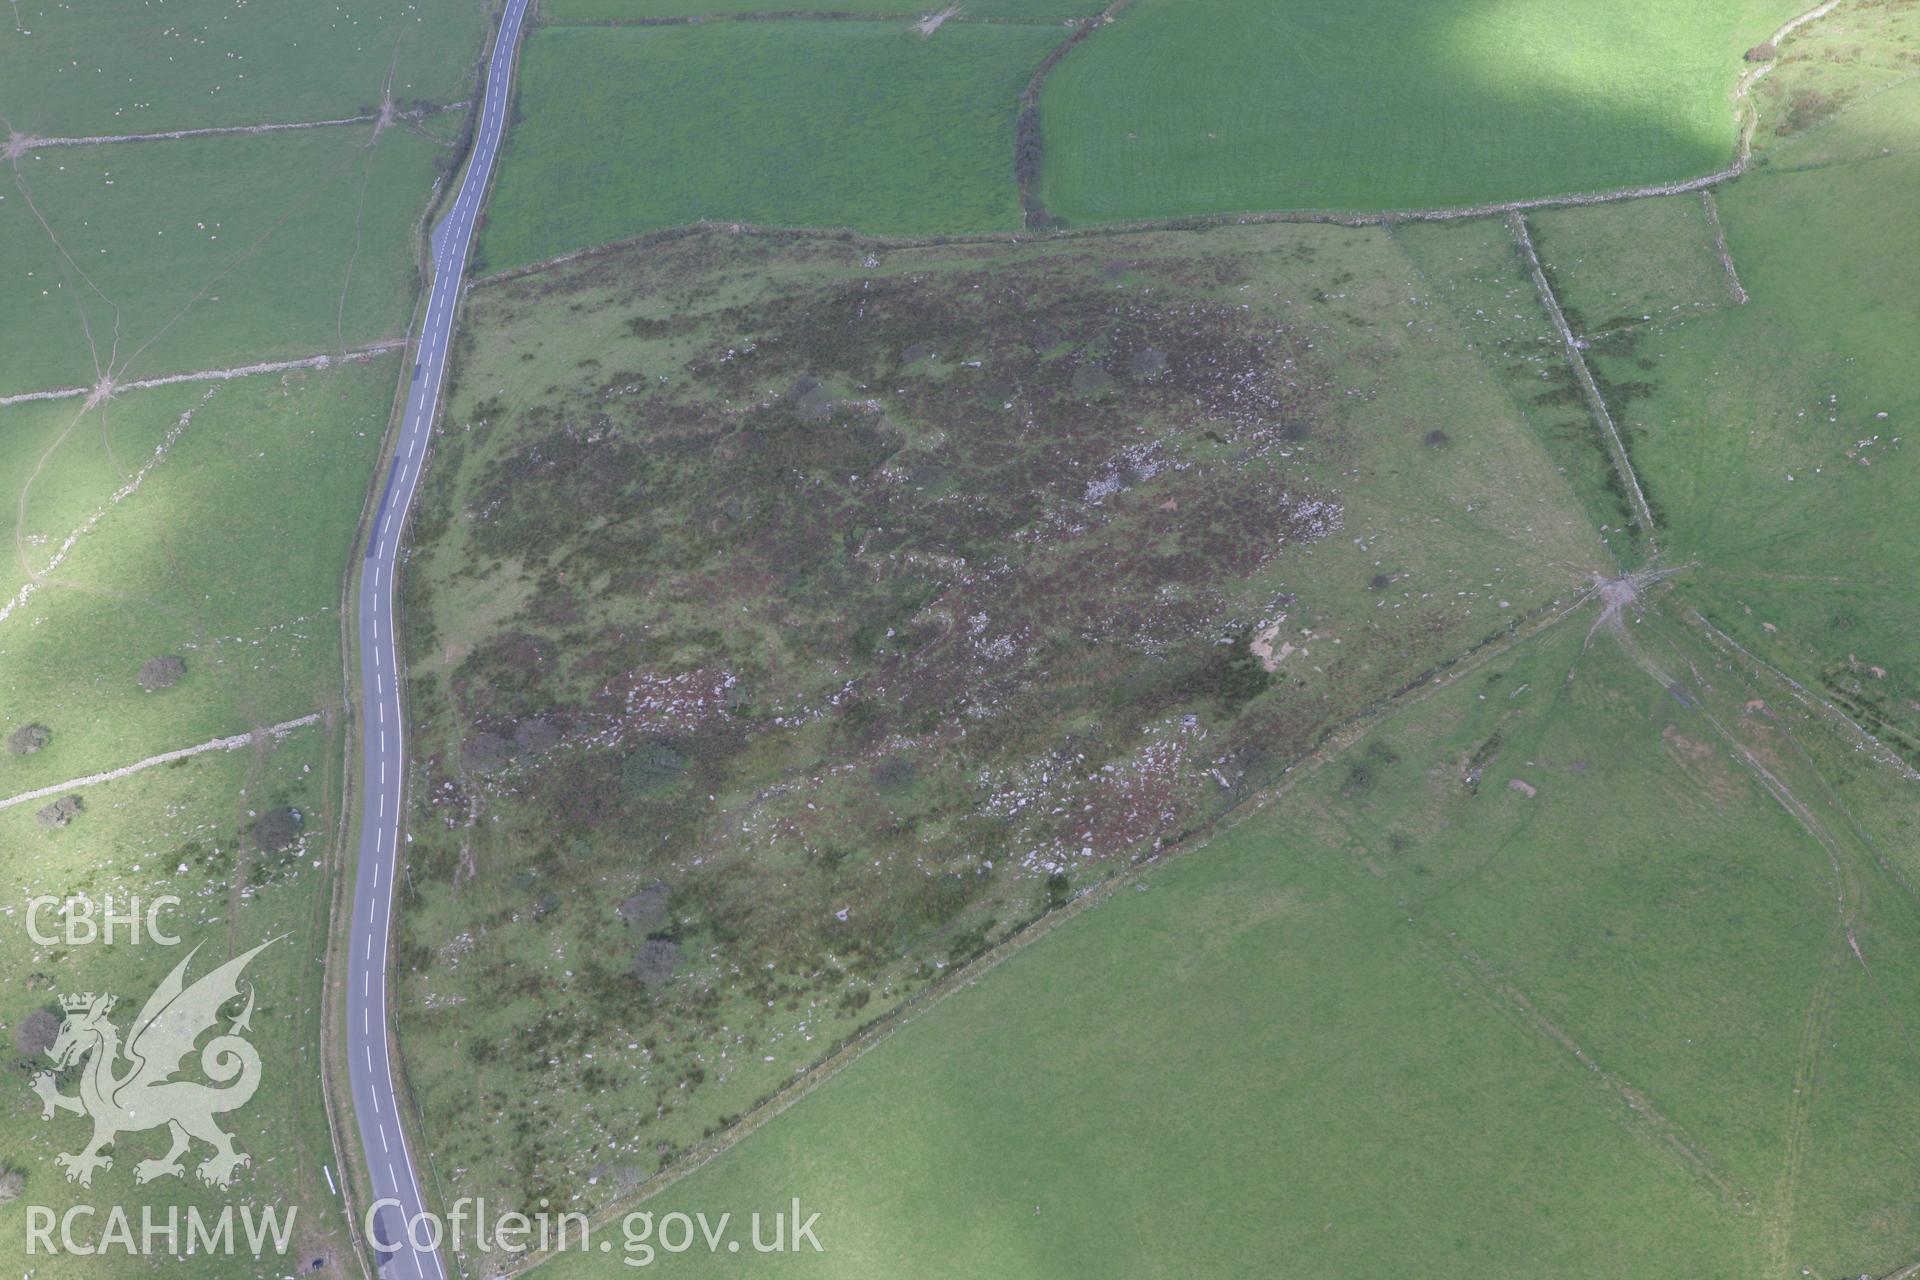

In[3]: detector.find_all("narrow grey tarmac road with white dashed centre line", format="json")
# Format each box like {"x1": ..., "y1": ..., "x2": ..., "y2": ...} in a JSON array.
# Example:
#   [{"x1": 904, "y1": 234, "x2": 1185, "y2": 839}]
[{"x1": 348, "y1": 0, "x2": 526, "y2": 1280}]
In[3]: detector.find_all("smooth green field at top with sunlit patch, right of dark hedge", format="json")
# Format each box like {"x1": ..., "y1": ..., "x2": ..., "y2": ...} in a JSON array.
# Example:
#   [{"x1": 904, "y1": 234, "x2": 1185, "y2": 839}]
[{"x1": 1037, "y1": 0, "x2": 1805, "y2": 223}]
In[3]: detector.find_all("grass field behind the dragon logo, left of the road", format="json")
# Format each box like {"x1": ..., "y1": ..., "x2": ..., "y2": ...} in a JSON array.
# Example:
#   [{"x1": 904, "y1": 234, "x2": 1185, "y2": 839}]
[{"x1": 0, "y1": 725, "x2": 357, "y2": 1278}]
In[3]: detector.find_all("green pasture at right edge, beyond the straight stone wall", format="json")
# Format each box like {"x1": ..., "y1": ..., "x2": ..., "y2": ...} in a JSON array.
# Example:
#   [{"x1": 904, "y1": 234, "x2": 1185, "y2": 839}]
[{"x1": 1512, "y1": 6, "x2": 1920, "y2": 762}]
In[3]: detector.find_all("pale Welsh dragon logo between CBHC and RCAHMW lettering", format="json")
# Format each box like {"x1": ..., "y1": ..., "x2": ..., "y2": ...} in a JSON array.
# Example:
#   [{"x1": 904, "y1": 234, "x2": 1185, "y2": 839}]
[{"x1": 33, "y1": 938, "x2": 278, "y2": 1186}]
